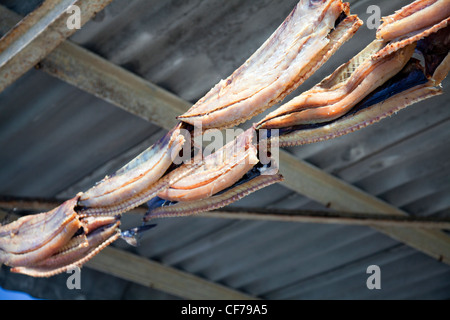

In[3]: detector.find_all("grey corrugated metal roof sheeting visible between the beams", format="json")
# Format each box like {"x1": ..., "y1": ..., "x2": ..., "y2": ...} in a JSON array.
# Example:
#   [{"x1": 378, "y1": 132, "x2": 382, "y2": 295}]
[{"x1": 0, "y1": 0, "x2": 450, "y2": 299}]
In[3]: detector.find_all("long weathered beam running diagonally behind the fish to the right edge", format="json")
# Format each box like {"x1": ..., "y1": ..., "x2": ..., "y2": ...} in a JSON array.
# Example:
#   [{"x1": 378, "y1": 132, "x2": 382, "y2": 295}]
[{"x1": 0, "y1": 7, "x2": 450, "y2": 264}]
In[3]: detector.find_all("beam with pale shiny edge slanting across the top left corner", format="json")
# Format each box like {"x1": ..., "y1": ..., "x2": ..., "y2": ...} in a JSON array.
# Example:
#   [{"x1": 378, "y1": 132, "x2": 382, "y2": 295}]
[{"x1": 0, "y1": 0, "x2": 112, "y2": 92}]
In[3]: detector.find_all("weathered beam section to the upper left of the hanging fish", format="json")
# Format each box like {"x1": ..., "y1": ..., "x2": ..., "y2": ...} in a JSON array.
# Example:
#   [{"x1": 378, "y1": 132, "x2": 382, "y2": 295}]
[{"x1": 0, "y1": 6, "x2": 191, "y2": 130}]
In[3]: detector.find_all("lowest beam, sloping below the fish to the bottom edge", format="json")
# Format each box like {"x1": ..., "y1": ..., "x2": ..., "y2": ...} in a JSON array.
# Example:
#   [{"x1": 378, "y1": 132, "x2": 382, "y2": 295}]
[{"x1": 0, "y1": 210, "x2": 255, "y2": 300}]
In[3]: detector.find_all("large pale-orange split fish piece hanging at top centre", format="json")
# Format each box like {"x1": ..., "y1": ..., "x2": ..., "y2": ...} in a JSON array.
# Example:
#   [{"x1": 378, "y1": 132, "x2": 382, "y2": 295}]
[{"x1": 178, "y1": 0, "x2": 362, "y2": 129}]
